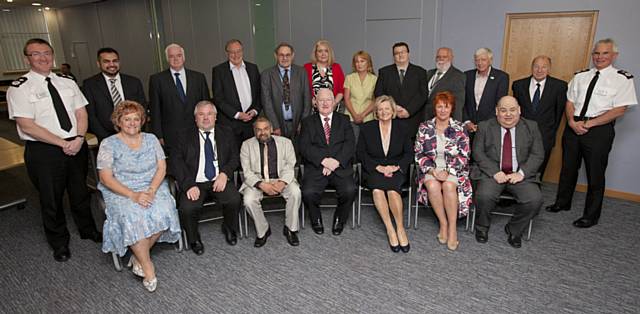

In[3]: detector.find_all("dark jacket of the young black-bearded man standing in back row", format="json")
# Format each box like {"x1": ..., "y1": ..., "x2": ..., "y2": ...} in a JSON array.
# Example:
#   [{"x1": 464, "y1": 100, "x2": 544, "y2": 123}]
[{"x1": 82, "y1": 73, "x2": 147, "y2": 141}]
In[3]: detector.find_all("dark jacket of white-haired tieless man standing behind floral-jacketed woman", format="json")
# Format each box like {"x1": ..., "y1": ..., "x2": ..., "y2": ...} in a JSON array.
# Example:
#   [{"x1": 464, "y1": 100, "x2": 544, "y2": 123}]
[{"x1": 462, "y1": 67, "x2": 509, "y2": 124}]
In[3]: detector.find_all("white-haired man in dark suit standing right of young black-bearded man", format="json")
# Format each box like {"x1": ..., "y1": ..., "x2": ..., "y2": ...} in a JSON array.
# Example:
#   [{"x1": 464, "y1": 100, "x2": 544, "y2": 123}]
[{"x1": 149, "y1": 44, "x2": 209, "y2": 157}]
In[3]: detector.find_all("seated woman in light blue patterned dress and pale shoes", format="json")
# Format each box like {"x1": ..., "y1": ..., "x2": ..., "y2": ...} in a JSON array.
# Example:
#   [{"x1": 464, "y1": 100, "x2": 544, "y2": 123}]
[{"x1": 97, "y1": 101, "x2": 181, "y2": 292}]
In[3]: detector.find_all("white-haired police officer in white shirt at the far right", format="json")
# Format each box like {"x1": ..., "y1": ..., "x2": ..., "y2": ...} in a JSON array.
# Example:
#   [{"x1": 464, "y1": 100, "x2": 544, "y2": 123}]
[{"x1": 547, "y1": 38, "x2": 638, "y2": 228}]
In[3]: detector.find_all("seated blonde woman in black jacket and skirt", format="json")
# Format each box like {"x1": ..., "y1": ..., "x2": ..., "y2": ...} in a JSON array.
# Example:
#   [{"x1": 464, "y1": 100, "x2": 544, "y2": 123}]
[{"x1": 358, "y1": 95, "x2": 413, "y2": 253}]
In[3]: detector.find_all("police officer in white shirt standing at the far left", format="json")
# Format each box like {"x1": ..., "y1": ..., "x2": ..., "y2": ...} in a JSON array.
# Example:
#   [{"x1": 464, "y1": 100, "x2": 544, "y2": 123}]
[{"x1": 7, "y1": 38, "x2": 102, "y2": 262}]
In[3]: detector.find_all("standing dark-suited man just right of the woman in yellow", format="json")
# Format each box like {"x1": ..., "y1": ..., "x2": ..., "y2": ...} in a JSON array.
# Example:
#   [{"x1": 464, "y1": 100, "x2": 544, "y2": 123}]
[{"x1": 373, "y1": 42, "x2": 427, "y2": 138}]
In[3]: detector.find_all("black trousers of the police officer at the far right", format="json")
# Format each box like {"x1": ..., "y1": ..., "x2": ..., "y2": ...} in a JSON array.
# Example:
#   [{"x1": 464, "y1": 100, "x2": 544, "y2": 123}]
[{"x1": 555, "y1": 118, "x2": 615, "y2": 222}]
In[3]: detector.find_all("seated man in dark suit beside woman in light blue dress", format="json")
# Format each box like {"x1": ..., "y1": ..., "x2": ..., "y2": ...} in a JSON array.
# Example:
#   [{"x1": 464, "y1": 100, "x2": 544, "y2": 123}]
[{"x1": 170, "y1": 100, "x2": 241, "y2": 255}]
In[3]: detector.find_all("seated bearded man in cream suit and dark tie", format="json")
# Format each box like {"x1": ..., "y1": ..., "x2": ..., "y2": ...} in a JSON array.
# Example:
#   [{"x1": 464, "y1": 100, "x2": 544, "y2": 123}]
[{"x1": 240, "y1": 117, "x2": 302, "y2": 247}]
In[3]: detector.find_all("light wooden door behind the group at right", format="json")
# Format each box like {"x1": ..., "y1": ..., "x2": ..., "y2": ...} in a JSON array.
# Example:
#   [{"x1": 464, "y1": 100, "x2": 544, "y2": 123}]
[{"x1": 502, "y1": 11, "x2": 598, "y2": 183}]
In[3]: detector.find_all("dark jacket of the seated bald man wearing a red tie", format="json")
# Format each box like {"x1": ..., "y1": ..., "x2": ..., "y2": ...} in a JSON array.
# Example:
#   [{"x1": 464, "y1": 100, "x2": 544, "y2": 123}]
[{"x1": 299, "y1": 112, "x2": 355, "y2": 178}]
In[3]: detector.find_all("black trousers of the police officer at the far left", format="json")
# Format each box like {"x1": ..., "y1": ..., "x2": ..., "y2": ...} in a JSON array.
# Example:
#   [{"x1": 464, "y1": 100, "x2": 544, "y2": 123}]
[{"x1": 24, "y1": 141, "x2": 96, "y2": 249}]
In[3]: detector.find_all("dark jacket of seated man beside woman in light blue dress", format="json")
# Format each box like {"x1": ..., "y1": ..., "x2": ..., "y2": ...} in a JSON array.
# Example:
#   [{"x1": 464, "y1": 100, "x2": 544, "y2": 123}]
[{"x1": 169, "y1": 125, "x2": 240, "y2": 191}]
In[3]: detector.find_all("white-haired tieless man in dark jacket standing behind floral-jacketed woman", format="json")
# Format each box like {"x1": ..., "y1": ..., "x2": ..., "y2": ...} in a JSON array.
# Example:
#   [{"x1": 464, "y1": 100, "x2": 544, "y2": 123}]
[{"x1": 462, "y1": 48, "x2": 509, "y2": 135}]
